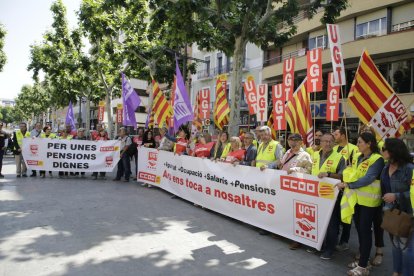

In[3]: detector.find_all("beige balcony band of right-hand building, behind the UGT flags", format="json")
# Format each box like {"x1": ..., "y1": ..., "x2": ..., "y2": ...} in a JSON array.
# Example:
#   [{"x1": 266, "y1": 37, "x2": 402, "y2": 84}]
[{"x1": 262, "y1": 28, "x2": 414, "y2": 80}]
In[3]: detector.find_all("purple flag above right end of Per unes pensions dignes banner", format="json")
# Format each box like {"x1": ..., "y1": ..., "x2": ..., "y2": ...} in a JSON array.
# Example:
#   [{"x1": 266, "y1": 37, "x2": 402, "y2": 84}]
[{"x1": 122, "y1": 73, "x2": 141, "y2": 129}]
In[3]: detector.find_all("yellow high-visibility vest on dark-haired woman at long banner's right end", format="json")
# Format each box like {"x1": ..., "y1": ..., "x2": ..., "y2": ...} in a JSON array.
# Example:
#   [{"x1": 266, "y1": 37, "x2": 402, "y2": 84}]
[{"x1": 341, "y1": 153, "x2": 382, "y2": 223}]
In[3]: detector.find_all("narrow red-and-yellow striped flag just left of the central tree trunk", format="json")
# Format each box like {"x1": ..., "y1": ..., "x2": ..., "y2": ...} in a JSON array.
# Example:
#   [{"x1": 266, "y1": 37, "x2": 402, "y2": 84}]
[{"x1": 213, "y1": 75, "x2": 230, "y2": 130}]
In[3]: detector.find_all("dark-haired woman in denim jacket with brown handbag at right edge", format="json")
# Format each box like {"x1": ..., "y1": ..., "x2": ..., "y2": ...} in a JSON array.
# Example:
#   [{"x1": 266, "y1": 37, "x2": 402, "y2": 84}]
[{"x1": 381, "y1": 138, "x2": 414, "y2": 276}]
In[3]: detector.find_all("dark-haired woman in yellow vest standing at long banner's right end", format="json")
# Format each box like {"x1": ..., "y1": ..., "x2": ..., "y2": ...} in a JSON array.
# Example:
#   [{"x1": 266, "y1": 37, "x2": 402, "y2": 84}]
[{"x1": 338, "y1": 132, "x2": 384, "y2": 275}]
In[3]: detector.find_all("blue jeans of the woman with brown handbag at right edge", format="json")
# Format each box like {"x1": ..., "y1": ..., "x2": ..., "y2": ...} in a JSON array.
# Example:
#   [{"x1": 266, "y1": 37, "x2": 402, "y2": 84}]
[{"x1": 392, "y1": 235, "x2": 414, "y2": 276}]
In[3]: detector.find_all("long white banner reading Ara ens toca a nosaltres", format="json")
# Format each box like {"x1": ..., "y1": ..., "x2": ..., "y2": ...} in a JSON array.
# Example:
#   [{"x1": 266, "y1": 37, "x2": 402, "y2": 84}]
[{"x1": 138, "y1": 148, "x2": 339, "y2": 249}]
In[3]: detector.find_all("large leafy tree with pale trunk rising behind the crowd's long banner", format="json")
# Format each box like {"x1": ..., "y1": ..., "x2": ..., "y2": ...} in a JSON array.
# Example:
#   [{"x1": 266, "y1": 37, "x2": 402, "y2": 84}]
[{"x1": 150, "y1": 0, "x2": 347, "y2": 135}]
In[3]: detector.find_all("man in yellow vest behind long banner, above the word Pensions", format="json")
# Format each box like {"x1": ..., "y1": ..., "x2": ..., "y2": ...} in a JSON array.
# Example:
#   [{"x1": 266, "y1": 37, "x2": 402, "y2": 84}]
[{"x1": 252, "y1": 126, "x2": 283, "y2": 170}]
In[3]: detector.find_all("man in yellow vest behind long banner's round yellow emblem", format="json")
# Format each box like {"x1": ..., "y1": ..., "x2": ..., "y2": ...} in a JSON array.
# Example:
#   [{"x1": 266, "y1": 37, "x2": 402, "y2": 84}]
[{"x1": 312, "y1": 133, "x2": 346, "y2": 260}]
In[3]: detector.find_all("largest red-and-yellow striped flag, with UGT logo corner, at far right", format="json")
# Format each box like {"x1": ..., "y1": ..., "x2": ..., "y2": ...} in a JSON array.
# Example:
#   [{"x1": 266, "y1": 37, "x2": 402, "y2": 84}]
[{"x1": 348, "y1": 50, "x2": 414, "y2": 138}]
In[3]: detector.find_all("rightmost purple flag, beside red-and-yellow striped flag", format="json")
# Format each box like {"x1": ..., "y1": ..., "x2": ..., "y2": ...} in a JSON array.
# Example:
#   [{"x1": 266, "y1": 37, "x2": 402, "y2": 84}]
[{"x1": 174, "y1": 59, "x2": 194, "y2": 132}]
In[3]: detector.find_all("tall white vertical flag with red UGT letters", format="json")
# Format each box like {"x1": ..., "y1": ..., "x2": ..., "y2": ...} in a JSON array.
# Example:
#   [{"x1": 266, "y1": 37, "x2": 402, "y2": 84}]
[{"x1": 326, "y1": 24, "x2": 346, "y2": 86}]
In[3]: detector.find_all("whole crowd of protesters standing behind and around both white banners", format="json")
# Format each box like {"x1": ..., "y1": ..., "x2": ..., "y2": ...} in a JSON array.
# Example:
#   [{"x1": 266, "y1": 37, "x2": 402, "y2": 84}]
[{"x1": 0, "y1": 123, "x2": 414, "y2": 276}]
